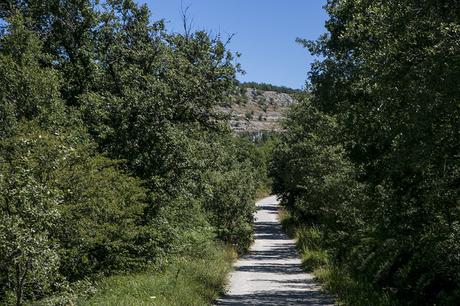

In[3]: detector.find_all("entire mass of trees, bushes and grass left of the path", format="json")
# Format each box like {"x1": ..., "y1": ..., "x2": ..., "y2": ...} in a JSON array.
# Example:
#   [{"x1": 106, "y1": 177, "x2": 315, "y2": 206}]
[{"x1": 0, "y1": 0, "x2": 266, "y2": 305}]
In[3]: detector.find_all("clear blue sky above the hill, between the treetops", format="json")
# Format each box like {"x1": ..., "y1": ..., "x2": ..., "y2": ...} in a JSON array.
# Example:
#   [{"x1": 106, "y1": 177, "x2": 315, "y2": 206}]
[{"x1": 140, "y1": 0, "x2": 327, "y2": 88}]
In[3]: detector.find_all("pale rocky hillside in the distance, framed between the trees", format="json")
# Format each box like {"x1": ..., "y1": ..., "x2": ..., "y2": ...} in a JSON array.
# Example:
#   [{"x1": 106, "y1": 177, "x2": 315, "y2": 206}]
[{"x1": 224, "y1": 87, "x2": 295, "y2": 134}]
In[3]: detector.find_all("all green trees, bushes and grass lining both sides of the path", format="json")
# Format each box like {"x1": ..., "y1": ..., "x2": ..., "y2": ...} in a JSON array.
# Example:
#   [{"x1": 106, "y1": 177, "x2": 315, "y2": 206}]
[{"x1": 0, "y1": 0, "x2": 460, "y2": 306}]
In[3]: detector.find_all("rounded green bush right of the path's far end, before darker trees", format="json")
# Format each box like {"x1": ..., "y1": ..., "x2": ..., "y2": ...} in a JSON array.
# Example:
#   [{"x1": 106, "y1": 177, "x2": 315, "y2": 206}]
[{"x1": 270, "y1": 98, "x2": 363, "y2": 234}]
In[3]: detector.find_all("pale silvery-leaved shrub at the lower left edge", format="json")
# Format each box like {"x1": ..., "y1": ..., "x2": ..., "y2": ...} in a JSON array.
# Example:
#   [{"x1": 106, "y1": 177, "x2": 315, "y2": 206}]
[{"x1": 0, "y1": 147, "x2": 62, "y2": 305}]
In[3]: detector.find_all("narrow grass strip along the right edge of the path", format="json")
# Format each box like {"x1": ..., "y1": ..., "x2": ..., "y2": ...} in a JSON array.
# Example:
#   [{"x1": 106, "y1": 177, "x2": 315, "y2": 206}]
[{"x1": 280, "y1": 210, "x2": 393, "y2": 306}]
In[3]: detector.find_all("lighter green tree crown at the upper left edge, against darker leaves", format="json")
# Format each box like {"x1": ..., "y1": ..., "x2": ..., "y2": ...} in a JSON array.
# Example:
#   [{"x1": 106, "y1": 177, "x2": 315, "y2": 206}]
[{"x1": 0, "y1": 15, "x2": 64, "y2": 137}]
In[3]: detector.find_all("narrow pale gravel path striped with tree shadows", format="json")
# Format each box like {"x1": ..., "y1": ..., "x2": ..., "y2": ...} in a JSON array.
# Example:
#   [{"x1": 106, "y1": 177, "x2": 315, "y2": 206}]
[{"x1": 216, "y1": 196, "x2": 334, "y2": 306}]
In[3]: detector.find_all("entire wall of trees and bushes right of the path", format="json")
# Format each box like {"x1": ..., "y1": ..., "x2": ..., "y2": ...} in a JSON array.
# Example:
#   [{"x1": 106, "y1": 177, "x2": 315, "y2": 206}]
[{"x1": 271, "y1": 0, "x2": 460, "y2": 305}]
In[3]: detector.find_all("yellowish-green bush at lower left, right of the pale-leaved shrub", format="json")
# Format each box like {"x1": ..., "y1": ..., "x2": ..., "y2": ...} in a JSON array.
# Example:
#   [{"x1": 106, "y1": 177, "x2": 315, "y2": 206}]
[{"x1": 55, "y1": 153, "x2": 146, "y2": 280}]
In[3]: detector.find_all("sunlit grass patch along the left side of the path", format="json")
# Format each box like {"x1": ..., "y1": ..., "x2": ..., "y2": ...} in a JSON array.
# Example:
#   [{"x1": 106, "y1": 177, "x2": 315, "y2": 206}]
[{"x1": 77, "y1": 245, "x2": 235, "y2": 306}]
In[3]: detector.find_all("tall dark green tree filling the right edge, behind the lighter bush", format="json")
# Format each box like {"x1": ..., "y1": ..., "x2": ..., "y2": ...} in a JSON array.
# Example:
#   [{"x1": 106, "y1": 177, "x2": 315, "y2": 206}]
[{"x1": 277, "y1": 0, "x2": 460, "y2": 305}]
